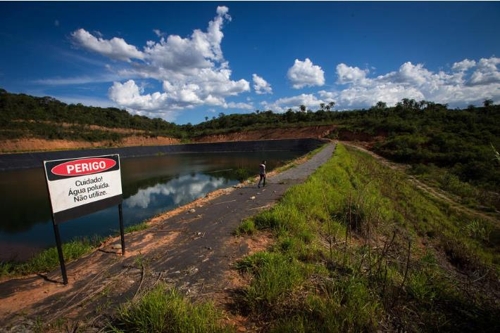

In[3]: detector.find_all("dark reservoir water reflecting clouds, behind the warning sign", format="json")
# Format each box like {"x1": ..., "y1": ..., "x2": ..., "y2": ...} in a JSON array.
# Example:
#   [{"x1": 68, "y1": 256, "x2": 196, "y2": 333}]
[{"x1": 0, "y1": 151, "x2": 307, "y2": 261}]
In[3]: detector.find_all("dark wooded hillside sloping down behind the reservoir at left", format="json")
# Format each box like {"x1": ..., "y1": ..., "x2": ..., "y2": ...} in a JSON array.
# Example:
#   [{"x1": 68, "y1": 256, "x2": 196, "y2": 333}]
[{"x1": 0, "y1": 89, "x2": 182, "y2": 142}]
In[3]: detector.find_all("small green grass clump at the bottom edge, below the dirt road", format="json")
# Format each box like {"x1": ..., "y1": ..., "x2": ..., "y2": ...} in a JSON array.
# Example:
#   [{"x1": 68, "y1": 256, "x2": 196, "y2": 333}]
[{"x1": 108, "y1": 283, "x2": 235, "y2": 333}]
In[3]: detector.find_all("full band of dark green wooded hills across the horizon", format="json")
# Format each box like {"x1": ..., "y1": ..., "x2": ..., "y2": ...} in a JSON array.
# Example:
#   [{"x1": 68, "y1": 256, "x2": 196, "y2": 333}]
[{"x1": 0, "y1": 89, "x2": 500, "y2": 191}]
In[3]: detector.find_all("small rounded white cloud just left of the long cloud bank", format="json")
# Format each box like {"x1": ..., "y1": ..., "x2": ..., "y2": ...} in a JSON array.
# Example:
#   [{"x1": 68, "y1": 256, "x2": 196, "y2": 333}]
[{"x1": 287, "y1": 58, "x2": 325, "y2": 89}]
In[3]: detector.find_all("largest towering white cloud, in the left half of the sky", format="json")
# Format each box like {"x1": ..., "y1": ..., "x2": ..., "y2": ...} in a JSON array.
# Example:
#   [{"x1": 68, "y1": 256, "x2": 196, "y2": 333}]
[{"x1": 72, "y1": 6, "x2": 250, "y2": 120}]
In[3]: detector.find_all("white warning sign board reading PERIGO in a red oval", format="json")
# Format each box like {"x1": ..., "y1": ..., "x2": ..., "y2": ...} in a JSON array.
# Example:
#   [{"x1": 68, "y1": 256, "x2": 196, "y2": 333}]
[{"x1": 44, "y1": 155, "x2": 122, "y2": 223}]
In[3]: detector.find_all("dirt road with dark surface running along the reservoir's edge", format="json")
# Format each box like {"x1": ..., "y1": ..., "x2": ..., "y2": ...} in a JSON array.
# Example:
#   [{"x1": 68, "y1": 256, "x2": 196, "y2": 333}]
[{"x1": 0, "y1": 143, "x2": 335, "y2": 332}]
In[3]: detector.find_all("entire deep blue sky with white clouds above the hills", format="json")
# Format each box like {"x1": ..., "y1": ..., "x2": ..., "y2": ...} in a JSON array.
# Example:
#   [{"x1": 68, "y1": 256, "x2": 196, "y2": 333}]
[{"x1": 0, "y1": 1, "x2": 500, "y2": 124}]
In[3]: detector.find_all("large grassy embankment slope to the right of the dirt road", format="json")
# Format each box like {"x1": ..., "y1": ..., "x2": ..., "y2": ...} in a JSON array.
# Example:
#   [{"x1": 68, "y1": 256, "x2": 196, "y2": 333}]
[{"x1": 232, "y1": 144, "x2": 500, "y2": 332}]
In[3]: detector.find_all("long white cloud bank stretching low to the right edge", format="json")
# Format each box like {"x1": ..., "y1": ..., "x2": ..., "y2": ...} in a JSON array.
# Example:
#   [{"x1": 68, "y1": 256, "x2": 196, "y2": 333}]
[{"x1": 262, "y1": 57, "x2": 500, "y2": 112}]
